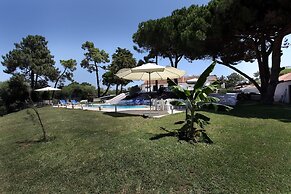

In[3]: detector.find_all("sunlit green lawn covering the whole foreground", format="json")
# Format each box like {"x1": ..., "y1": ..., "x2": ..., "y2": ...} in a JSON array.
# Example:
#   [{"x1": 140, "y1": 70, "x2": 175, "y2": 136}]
[{"x1": 0, "y1": 105, "x2": 291, "y2": 193}]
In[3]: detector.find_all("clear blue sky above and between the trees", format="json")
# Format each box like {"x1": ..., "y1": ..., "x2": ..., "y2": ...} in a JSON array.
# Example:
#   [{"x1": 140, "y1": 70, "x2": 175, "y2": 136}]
[{"x1": 0, "y1": 0, "x2": 291, "y2": 85}]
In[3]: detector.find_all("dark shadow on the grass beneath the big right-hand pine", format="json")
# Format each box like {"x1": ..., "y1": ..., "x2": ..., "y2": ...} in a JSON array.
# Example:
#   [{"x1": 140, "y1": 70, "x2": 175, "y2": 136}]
[{"x1": 209, "y1": 104, "x2": 291, "y2": 122}]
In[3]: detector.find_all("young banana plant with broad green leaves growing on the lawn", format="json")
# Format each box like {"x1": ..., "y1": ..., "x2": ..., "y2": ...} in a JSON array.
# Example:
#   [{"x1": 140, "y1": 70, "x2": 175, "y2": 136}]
[{"x1": 168, "y1": 62, "x2": 232, "y2": 143}]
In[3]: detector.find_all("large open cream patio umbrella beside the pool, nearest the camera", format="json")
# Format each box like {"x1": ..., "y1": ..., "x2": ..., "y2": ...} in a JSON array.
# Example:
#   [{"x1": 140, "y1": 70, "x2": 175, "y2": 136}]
[{"x1": 116, "y1": 63, "x2": 186, "y2": 111}]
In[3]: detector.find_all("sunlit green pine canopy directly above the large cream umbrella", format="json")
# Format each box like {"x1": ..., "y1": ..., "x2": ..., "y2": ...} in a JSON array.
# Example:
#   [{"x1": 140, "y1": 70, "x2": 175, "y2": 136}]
[{"x1": 133, "y1": 6, "x2": 208, "y2": 68}]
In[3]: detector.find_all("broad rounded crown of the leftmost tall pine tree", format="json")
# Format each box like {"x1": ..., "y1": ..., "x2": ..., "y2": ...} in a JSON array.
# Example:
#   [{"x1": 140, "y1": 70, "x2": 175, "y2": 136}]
[{"x1": 2, "y1": 35, "x2": 58, "y2": 89}]
